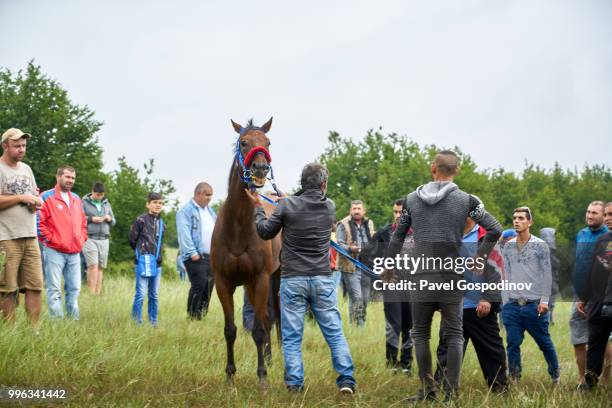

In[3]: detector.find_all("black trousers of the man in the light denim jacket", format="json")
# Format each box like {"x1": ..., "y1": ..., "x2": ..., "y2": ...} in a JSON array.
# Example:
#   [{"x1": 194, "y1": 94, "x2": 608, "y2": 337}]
[{"x1": 185, "y1": 255, "x2": 215, "y2": 320}]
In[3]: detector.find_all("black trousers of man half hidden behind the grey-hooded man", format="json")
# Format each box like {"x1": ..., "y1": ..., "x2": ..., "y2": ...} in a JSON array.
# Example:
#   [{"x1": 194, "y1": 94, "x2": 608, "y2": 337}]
[{"x1": 435, "y1": 308, "x2": 508, "y2": 388}]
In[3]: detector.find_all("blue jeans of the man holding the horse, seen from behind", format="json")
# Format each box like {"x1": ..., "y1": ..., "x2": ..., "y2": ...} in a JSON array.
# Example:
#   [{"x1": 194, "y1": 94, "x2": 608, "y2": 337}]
[{"x1": 280, "y1": 276, "x2": 355, "y2": 387}]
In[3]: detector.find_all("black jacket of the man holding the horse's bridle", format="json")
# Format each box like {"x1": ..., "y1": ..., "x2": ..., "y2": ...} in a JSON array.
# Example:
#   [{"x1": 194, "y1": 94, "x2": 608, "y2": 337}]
[{"x1": 255, "y1": 189, "x2": 336, "y2": 277}]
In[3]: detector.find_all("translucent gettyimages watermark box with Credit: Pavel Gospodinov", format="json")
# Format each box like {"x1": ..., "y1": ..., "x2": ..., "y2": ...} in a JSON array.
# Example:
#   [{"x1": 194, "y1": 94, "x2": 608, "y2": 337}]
[{"x1": 359, "y1": 240, "x2": 595, "y2": 304}]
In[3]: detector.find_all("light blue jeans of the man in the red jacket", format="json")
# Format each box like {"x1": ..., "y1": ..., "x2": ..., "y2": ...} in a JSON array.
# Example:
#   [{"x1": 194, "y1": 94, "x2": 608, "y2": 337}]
[{"x1": 43, "y1": 247, "x2": 81, "y2": 320}]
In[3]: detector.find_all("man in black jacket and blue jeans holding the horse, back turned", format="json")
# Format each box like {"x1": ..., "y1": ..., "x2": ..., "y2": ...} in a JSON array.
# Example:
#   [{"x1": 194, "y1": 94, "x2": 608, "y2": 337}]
[{"x1": 247, "y1": 163, "x2": 355, "y2": 394}]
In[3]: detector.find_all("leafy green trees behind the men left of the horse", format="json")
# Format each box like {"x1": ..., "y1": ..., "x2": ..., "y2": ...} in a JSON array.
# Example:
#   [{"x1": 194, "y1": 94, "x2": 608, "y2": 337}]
[{"x1": 0, "y1": 61, "x2": 178, "y2": 262}]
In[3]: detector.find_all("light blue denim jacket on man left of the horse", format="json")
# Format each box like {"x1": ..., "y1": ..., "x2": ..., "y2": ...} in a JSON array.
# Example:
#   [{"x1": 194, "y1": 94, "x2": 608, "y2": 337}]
[{"x1": 176, "y1": 200, "x2": 217, "y2": 261}]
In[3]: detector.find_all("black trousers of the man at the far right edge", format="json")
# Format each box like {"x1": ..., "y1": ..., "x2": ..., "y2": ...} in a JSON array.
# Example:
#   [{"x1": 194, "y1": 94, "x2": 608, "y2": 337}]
[{"x1": 586, "y1": 313, "x2": 612, "y2": 386}]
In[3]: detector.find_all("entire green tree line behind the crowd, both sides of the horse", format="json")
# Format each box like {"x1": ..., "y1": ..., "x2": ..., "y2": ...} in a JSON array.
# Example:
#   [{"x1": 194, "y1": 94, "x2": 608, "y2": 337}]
[{"x1": 0, "y1": 61, "x2": 612, "y2": 284}]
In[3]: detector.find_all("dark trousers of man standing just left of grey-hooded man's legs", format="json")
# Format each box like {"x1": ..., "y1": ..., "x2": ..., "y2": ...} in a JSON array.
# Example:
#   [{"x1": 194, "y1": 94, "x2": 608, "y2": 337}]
[{"x1": 384, "y1": 302, "x2": 412, "y2": 368}]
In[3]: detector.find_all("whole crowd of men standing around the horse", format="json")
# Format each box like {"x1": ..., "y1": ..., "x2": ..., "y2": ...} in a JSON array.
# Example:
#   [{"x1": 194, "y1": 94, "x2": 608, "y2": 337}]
[{"x1": 0, "y1": 128, "x2": 612, "y2": 401}]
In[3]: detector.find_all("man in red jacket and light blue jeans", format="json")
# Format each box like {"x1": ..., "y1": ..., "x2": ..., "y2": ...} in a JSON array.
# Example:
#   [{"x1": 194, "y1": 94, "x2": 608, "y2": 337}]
[{"x1": 38, "y1": 166, "x2": 87, "y2": 320}]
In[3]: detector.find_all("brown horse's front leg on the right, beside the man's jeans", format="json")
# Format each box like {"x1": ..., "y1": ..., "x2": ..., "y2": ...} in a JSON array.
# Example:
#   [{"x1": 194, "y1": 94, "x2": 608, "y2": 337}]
[{"x1": 247, "y1": 275, "x2": 270, "y2": 389}]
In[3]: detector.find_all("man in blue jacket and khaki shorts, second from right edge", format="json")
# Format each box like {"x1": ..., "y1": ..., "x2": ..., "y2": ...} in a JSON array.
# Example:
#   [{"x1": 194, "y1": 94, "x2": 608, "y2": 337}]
[{"x1": 570, "y1": 201, "x2": 608, "y2": 387}]
